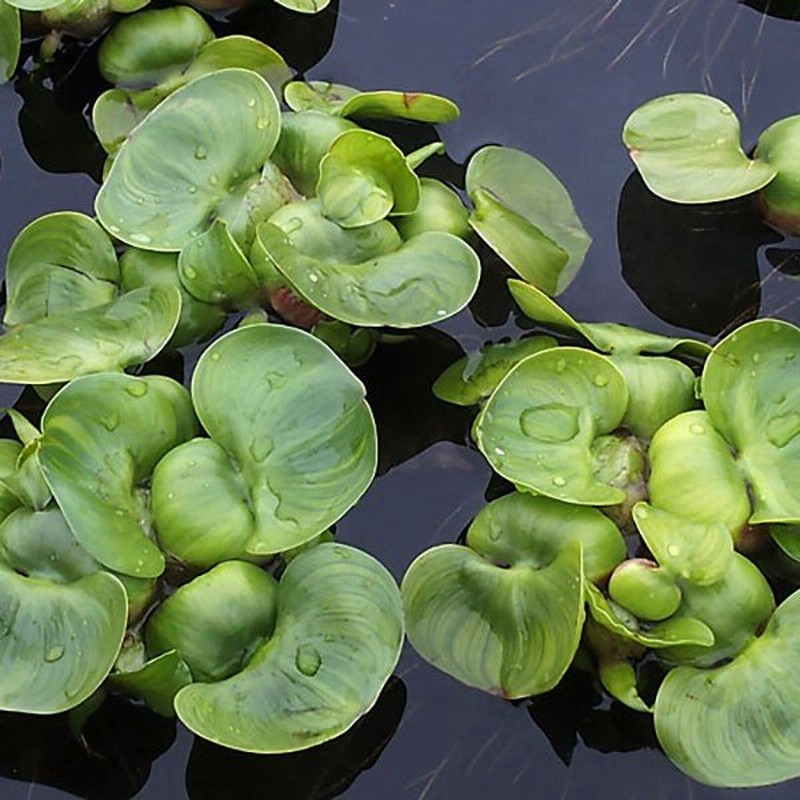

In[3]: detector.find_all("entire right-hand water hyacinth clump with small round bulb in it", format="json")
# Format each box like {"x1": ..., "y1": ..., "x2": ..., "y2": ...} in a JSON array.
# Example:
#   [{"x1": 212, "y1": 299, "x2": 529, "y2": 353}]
[{"x1": 401, "y1": 280, "x2": 800, "y2": 786}]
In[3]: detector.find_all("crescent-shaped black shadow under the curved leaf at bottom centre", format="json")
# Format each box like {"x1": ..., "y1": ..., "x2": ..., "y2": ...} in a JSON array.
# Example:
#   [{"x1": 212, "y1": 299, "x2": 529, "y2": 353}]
[{"x1": 186, "y1": 677, "x2": 406, "y2": 800}]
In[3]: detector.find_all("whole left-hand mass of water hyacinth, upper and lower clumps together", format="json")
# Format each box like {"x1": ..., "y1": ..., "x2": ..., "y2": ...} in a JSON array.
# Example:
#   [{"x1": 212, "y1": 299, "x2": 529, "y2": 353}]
[{"x1": 0, "y1": 0, "x2": 589, "y2": 764}]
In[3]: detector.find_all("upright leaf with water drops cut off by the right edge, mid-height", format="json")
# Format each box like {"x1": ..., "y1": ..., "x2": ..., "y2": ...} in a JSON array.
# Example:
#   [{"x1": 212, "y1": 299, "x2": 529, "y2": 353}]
[{"x1": 701, "y1": 319, "x2": 800, "y2": 524}]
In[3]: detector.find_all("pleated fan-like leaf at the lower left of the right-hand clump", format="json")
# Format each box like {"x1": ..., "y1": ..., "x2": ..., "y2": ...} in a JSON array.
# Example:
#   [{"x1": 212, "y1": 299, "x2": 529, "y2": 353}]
[{"x1": 401, "y1": 541, "x2": 584, "y2": 698}]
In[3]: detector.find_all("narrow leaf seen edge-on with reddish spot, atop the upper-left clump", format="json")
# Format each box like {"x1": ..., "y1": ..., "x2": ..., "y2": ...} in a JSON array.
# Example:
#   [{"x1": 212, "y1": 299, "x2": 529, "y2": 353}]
[{"x1": 284, "y1": 81, "x2": 459, "y2": 123}]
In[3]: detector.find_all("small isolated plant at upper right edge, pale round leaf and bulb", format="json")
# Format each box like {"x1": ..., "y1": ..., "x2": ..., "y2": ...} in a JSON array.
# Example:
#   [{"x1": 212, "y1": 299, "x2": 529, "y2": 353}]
[{"x1": 622, "y1": 94, "x2": 800, "y2": 234}]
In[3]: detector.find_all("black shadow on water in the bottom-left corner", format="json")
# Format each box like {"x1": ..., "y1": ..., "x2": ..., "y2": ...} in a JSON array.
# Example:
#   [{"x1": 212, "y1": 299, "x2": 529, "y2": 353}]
[{"x1": 0, "y1": 698, "x2": 173, "y2": 800}]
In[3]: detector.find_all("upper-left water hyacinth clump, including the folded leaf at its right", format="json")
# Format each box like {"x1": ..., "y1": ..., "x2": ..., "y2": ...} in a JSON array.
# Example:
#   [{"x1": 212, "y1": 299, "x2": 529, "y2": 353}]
[{"x1": 0, "y1": 7, "x2": 590, "y2": 384}]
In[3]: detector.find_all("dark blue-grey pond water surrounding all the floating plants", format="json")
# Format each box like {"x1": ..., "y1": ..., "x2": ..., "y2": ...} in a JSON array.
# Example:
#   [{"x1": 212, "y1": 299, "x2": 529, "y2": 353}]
[{"x1": 0, "y1": 0, "x2": 800, "y2": 800}]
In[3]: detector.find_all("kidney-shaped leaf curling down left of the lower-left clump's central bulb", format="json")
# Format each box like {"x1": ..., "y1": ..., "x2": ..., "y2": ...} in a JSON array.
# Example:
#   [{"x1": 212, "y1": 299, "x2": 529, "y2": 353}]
[{"x1": 39, "y1": 374, "x2": 196, "y2": 577}]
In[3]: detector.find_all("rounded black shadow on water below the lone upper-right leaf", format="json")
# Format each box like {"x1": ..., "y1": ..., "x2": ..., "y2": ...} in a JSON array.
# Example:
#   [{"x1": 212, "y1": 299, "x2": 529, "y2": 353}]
[{"x1": 617, "y1": 172, "x2": 782, "y2": 336}]
